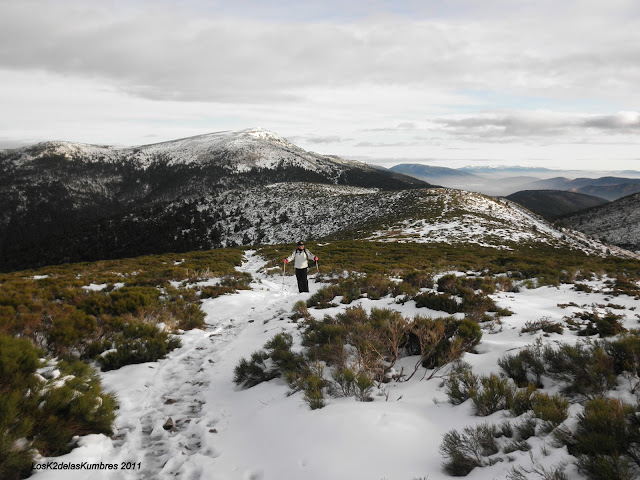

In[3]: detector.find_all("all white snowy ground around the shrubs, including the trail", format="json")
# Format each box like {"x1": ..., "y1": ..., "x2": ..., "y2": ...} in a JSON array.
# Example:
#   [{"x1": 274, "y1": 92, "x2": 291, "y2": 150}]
[{"x1": 31, "y1": 252, "x2": 638, "y2": 480}]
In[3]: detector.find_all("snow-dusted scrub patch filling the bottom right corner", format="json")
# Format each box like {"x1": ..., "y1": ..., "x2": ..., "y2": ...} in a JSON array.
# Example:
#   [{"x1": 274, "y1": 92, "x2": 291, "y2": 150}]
[{"x1": 440, "y1": 332, "x2": 640, "y2": 480}]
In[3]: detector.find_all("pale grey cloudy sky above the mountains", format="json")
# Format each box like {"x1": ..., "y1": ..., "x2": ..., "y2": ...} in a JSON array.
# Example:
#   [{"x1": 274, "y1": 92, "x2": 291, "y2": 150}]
[{"x1": 0, "y1": 0, "x2": 640, "y2": 170}]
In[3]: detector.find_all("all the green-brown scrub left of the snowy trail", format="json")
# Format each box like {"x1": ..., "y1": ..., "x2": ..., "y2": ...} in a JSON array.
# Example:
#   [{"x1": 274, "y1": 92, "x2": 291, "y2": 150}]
[{"x1": 0, "y1": 249, "x2": 250, "y2": 480}]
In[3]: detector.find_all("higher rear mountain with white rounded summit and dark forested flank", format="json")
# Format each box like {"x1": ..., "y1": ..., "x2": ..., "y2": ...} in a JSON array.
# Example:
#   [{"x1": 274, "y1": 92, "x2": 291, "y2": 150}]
[{"x1": 0, "y1": 128, "x2": 430, "y2": 270}]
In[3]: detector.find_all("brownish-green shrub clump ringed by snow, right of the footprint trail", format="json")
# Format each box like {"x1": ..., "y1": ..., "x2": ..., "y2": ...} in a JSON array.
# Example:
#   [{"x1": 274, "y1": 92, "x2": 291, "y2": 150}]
[{"x1": 234, "y1": 305, "x2": 482, "y2": 408}]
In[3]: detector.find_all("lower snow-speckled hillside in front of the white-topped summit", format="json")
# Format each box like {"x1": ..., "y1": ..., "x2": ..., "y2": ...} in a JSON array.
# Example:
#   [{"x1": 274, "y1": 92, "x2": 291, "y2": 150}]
[{"x1": 65, "y1": 183, "x2": 633, "y2": 266}]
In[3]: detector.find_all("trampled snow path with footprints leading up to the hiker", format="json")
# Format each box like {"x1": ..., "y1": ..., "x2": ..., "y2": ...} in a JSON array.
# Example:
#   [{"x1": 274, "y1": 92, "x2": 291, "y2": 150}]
[{"x1": 99, "y1": 251, "x2": 315, "y2": 479}]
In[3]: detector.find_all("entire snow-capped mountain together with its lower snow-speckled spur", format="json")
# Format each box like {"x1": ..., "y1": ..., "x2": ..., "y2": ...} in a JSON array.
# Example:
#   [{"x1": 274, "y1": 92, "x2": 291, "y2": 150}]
[{"x1": 0, "y1": 129, "x2": 626, "y2": 271}]
